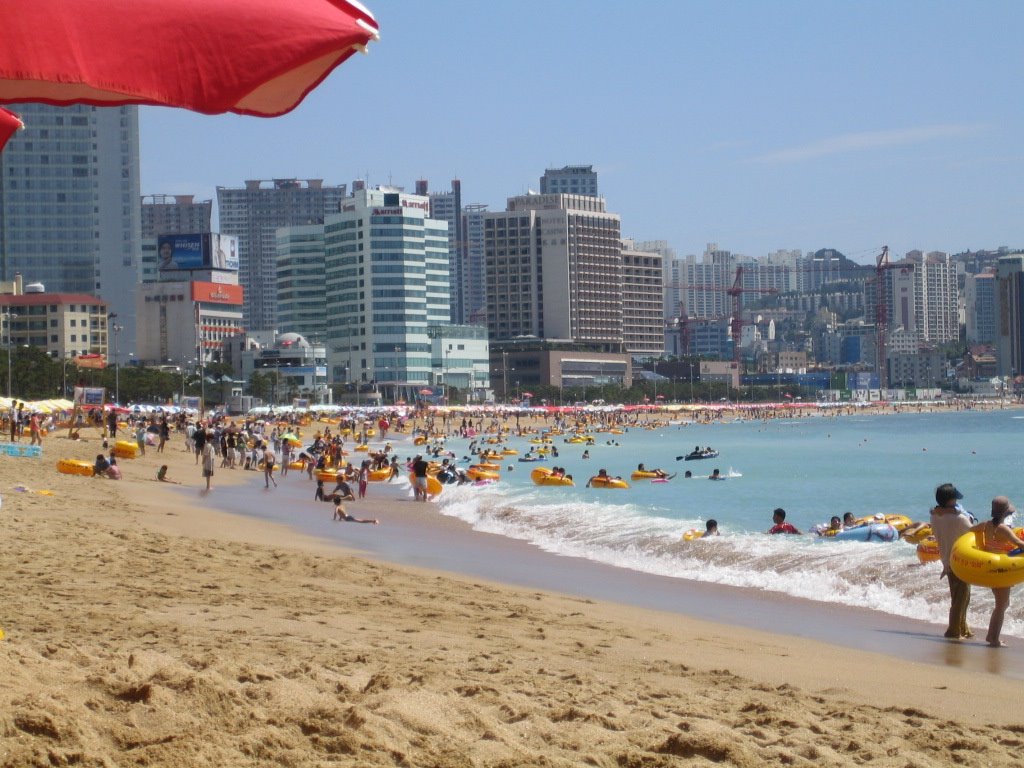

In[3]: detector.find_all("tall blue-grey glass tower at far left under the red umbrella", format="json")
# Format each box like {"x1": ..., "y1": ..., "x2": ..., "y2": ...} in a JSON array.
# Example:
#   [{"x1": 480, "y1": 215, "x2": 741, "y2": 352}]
[{"x1": 0, "y1": 103, "x2": 140, "y2": 353}]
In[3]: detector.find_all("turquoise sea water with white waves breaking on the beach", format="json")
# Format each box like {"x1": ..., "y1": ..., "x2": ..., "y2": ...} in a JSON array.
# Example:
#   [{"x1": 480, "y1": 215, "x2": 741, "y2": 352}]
[{"x1": 430, "y1": 410, "x2": 1024, "y2": 637}]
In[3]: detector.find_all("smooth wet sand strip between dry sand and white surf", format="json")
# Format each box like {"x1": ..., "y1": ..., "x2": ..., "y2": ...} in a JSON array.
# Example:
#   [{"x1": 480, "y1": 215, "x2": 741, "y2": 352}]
[{"x1": 188, "y1": 456, "x2": 1024, "y2": 680}]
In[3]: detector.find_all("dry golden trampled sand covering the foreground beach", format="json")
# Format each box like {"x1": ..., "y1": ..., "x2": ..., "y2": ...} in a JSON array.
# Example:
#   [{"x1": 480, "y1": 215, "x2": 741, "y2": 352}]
[{"x1": 0, "y1": 421, "x2": 1024, "y2": 766}]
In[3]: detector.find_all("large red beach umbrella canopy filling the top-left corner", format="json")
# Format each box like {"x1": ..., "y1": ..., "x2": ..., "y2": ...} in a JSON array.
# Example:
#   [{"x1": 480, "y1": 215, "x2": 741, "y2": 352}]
[{"x1": 0, "y1": 0, "x2": 378, "y2": 117}]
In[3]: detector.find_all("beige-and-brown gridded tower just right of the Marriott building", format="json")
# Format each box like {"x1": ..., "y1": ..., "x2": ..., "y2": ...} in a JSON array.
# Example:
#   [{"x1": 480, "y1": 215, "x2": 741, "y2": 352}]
[{"x1": 484, "y1": 195, "x2": 623, "y2": 352}]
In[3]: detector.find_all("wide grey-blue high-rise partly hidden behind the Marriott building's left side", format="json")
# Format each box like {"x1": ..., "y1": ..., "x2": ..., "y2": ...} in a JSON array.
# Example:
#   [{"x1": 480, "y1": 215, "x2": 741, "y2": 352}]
[{"x1": 217, "y1": 178, "x2": 346, "y2": 331}]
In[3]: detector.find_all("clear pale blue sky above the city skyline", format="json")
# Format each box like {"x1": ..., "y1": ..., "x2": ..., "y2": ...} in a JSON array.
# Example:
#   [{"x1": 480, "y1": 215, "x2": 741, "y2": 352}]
[{"x1": 141, "y1": 0, "x2": 1024, "y2": 261}]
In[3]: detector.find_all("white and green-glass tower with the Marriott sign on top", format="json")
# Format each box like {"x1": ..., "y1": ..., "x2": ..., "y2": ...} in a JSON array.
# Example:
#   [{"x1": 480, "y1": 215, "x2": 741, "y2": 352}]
[{"x1": 324, "y1": 187, "x2": 451, "y2": 385}]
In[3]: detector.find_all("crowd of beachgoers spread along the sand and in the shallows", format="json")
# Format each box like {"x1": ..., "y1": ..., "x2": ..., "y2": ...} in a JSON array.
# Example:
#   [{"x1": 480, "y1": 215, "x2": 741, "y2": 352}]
[{"x1": 14, "y1": 400, "x2": 1024, "y2": 647}]
